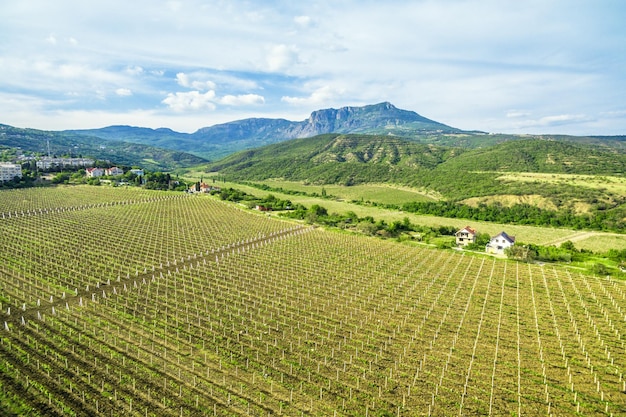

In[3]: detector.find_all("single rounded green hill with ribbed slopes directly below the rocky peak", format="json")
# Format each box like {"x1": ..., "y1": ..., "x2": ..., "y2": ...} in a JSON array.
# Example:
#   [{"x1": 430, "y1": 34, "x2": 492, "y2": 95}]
[{"x1": 209, "y1": 134, "x2": 463, "y2": 184}]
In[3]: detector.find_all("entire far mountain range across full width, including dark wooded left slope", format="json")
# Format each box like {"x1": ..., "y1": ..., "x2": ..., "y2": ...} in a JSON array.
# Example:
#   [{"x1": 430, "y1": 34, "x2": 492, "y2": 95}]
[{"x1": 0, "y1": 102, "x2": 626, "y2": 170}]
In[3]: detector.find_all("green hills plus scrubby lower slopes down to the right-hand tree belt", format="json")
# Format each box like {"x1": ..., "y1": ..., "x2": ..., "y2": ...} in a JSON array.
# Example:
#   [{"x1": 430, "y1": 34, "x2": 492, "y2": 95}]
[{"x1": 209, "y1": 134, "x2": 626, "y2": 231}]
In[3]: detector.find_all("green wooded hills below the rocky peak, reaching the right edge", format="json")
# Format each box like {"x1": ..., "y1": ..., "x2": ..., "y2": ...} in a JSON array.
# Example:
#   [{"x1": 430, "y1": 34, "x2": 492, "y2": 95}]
[{"x1": 208, "y1": 134, "x2": 626, "y2": 199}]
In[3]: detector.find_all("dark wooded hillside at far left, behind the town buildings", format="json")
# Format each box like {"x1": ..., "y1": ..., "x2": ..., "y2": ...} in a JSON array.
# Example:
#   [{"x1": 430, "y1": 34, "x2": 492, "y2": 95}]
[{"x1": 0, "y1": 125, "x2": 207, "y2": 170}]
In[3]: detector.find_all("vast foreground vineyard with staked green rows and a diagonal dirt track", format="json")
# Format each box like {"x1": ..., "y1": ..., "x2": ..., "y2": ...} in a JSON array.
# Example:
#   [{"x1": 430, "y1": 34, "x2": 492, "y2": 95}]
[{"x1": 0, "y1": 187, "x2": 626, "y2": 417}]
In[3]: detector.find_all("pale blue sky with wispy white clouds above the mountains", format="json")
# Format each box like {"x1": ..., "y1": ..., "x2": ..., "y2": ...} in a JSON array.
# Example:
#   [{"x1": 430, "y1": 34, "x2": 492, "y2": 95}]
[{"x1": 0, "y1": 0, "x2": 626, "y2": 135}]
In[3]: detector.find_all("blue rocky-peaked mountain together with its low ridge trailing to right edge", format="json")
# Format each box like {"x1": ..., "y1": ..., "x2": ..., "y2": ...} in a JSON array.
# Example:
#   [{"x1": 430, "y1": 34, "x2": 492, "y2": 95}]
[{"x1": 66, "y1": 102, "x2": 626, "y2": 161}]
